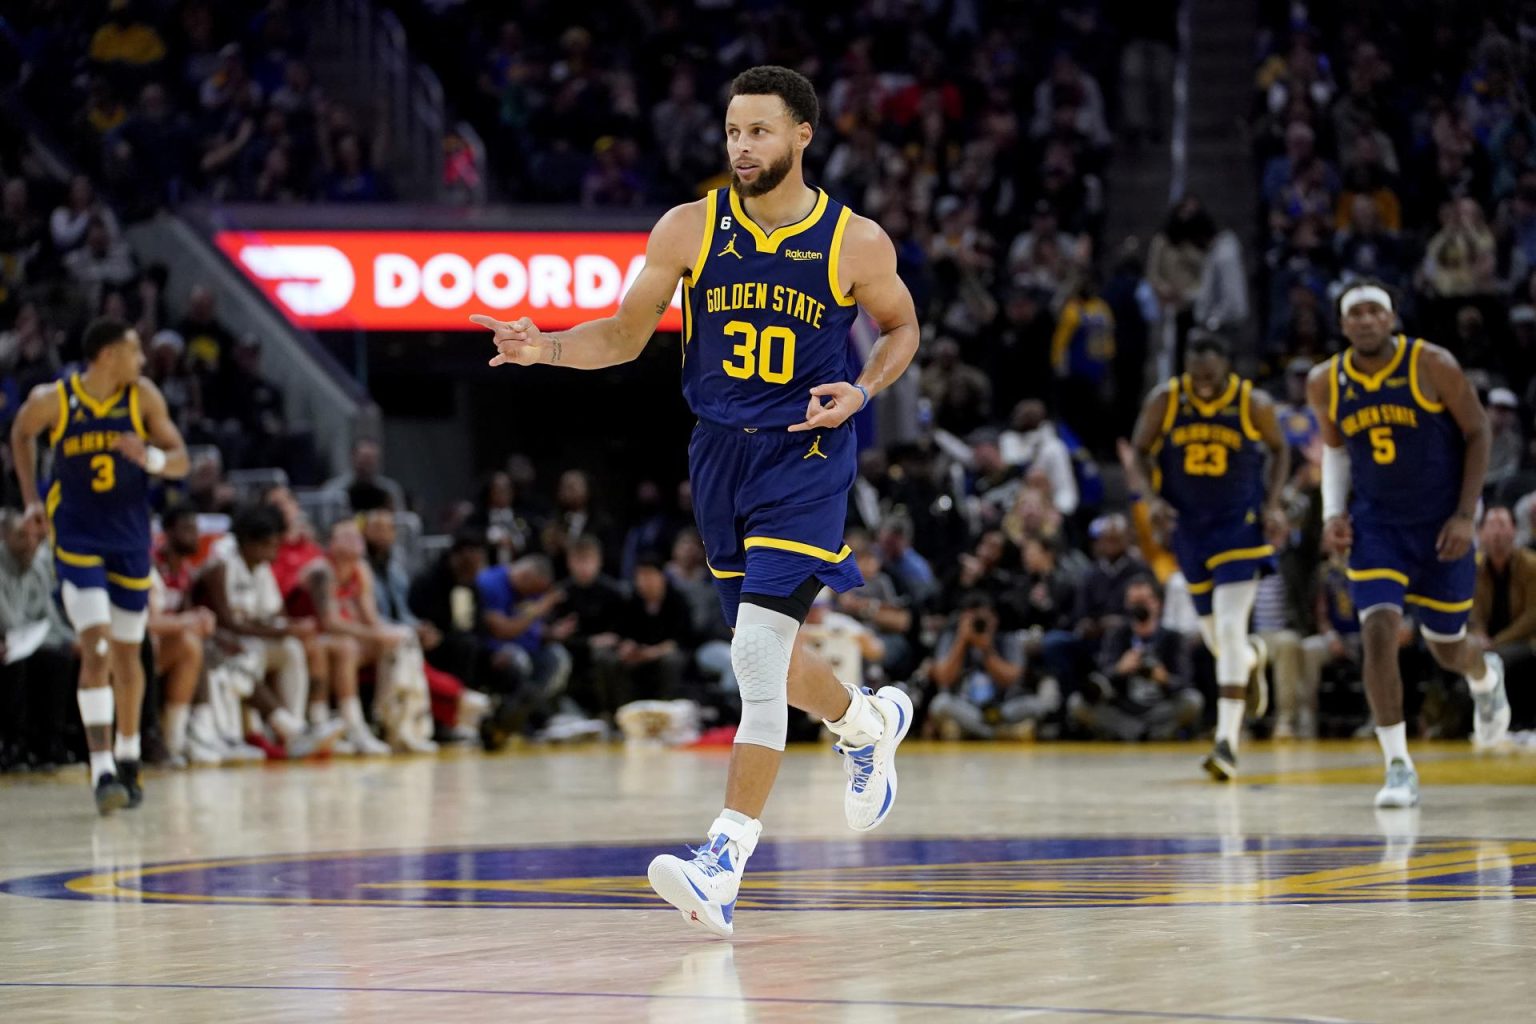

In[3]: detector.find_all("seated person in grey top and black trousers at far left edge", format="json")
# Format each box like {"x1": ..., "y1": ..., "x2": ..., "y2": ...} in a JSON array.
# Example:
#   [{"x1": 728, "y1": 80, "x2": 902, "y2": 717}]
[{"x1": 0, "y1": 508, "x2": 75, "y2": 771}]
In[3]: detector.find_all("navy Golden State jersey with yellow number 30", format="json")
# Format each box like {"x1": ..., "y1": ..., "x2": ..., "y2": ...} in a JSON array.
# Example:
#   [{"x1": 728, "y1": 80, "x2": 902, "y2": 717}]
[{"x1": 682, "y1": 189, "x2": 857, "y2": 430}]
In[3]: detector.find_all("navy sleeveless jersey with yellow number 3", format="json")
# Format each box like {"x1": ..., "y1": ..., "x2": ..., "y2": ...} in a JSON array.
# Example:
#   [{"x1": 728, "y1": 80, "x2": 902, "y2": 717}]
[{"x1": 48, "y1": 373, "x2": 149, "y2": 557}]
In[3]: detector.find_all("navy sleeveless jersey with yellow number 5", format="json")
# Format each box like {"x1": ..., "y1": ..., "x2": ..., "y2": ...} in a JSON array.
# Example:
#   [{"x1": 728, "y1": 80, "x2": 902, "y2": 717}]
[{"x1": 1329, "y1": 335, "x2": 1467, "y2": 525}]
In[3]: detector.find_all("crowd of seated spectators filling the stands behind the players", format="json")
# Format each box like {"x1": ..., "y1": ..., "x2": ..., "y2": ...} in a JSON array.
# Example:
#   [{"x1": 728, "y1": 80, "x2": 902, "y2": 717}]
[{"x1": 0, "y1": 0, "x2": 1536, "y2": 766}]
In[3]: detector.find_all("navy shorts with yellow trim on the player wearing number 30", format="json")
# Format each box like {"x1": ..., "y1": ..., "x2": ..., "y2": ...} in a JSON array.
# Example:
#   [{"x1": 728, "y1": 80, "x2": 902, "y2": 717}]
[{"x1": 688, "y1": 421, "x2": 865, "y2": 626}]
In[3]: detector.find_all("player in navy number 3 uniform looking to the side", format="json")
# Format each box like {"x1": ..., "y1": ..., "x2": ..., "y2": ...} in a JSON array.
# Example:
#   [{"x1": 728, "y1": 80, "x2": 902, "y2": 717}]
[{"x1": 11, "y1": 316, "x2": 187, "y2": 814}]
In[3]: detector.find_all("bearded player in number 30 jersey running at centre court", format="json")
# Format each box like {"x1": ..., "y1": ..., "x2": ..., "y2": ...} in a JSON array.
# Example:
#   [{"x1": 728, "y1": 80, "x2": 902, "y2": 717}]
[{"x1": 472, "y1": 66, "x2": 919, "y2": 935}]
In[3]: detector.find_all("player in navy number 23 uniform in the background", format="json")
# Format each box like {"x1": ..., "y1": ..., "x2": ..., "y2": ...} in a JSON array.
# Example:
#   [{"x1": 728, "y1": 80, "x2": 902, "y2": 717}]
[{"x1": 1132, "y1": 330, "x2": 1290, "y2": 781}]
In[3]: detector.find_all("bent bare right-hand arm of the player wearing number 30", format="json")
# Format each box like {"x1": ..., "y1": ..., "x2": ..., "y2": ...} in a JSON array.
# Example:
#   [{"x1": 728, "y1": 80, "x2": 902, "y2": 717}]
[{"x1": 790, "y1": 216, "x2": 919, "y2": 430}]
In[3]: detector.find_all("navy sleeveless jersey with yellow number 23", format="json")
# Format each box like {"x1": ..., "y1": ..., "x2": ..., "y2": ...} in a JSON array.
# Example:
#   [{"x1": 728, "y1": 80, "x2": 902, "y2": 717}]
[{"x1": 1155, "y1": 373, "x2": 1267, "y2": 520}]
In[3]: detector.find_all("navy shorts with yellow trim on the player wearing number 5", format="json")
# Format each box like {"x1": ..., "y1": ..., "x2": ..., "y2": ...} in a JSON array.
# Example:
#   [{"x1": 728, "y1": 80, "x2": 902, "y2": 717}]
[{"x1": 1349, "y1": 520, "x2": 1478, "y2": 639}]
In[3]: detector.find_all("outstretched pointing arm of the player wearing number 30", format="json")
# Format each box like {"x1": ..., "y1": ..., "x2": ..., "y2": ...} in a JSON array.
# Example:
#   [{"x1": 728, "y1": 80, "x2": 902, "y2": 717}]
[{"x1": 470, "y1": 203, "x2": 703, "y2": 370}]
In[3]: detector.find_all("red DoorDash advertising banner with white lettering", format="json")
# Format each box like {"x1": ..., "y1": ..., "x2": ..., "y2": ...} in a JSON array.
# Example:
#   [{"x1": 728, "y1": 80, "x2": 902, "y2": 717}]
[{"x1": 214, "y1": 230, "x2": 682, "y2": 330}]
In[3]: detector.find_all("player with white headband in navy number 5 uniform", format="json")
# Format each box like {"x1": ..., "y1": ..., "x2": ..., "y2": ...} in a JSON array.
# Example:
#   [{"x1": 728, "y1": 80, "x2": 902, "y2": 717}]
[{"x1": 1307, "y1": 281, "x2": 1510, "y2": 808}]
